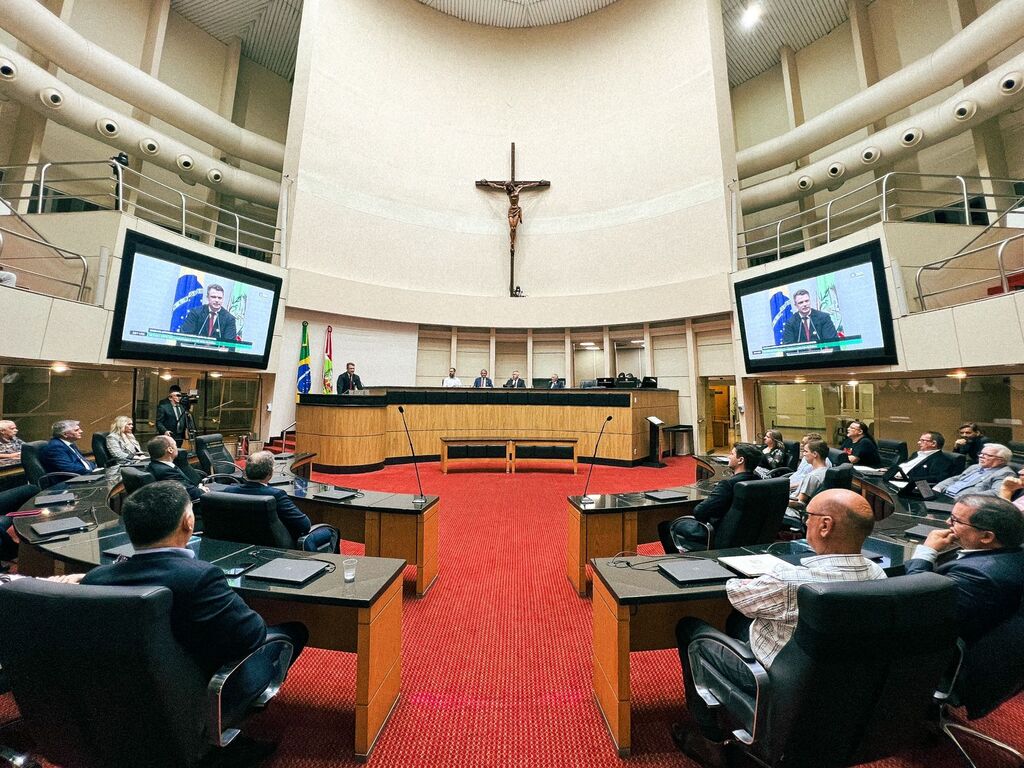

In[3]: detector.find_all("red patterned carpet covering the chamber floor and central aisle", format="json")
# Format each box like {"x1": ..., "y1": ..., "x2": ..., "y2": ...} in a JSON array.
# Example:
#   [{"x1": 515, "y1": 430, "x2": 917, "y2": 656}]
[{"x1": 4, "y1": 459, "x2": 1024, "y2": 768}]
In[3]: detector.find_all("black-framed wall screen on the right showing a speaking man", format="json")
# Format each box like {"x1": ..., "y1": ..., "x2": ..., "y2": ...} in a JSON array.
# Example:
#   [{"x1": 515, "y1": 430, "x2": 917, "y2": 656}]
[{"x1": 734, "y1": 241, "x2": 897, "y2": 374}]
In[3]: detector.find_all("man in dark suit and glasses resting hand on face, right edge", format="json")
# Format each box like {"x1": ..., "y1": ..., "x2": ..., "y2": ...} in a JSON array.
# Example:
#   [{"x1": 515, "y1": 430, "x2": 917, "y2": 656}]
[{"x1": 906, "y1": 494, "x2": 1024, "y2": 642}]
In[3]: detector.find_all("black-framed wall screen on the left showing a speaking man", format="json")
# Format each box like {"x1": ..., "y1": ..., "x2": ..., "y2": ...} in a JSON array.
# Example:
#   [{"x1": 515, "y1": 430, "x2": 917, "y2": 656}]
[{"x1": 106, "y1": 231, "x2": 282, "y2": 368}]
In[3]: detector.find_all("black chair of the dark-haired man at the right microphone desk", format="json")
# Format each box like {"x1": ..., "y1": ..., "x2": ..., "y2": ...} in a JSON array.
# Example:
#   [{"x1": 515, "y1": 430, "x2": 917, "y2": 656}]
[{"x1": 663, "y1": 477, "x2": 790, "y2": 552}]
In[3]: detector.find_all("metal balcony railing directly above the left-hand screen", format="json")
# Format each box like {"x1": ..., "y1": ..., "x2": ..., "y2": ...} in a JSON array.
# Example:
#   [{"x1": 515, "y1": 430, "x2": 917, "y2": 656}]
[{"x1": 4, "y1": 160, "x2": 282, "y2": 257}]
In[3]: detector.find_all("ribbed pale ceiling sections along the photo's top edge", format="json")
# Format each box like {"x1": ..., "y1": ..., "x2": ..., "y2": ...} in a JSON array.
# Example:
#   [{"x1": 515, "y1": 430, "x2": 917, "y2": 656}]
[{"x1": 171, "y1": 0, "x2": 871, "y2": 86}]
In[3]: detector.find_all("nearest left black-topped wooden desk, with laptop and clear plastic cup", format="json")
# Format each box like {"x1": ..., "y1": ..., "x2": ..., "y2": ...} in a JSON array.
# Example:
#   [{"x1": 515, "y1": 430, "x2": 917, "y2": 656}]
[{"x1": 14, "y1": 474, "x2": 406, "y2": 760}]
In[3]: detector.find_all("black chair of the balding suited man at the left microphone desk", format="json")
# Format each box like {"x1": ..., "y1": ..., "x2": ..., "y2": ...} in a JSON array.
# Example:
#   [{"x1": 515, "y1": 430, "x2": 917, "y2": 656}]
[{"x1": 203, "y1": 490, "x2": 341, "y2": 554}]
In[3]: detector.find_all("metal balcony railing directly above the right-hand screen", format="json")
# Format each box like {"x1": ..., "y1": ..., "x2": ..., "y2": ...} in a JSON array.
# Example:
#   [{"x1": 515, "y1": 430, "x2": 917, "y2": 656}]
[{"x1": 736, "y1": 171, "x2": 1019, "y2": 260}]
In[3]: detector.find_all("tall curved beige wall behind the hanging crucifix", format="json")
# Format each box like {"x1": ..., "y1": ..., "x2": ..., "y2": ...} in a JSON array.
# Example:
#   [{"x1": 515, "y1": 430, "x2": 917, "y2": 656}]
[{"x1": 286, "y1": 0, "x2": 734, "y2": 327}]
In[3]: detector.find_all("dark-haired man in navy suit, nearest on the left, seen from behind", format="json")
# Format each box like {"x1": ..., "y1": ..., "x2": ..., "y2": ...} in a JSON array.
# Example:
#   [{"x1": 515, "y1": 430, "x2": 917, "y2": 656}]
[{"x1": 82, "y1": 481, "x2": 308, "y2": 699}]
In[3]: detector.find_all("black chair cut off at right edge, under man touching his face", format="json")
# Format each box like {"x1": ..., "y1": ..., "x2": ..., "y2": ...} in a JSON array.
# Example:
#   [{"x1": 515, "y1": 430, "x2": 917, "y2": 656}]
[{"x1": 935, "y1": 604, "x2": 1024, "y2": 768}]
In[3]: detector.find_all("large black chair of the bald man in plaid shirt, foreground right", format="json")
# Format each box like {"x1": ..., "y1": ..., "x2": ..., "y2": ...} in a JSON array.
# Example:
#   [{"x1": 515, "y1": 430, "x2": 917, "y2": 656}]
[{"x1": 687, "y1": 573, "x2": 956, "y2": 768}]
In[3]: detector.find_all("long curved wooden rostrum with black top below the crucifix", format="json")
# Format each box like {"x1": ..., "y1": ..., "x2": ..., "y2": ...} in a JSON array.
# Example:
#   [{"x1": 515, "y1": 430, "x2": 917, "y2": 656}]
[{"x1": 295, "y1": 387, "x2": 679, "y2": 472}]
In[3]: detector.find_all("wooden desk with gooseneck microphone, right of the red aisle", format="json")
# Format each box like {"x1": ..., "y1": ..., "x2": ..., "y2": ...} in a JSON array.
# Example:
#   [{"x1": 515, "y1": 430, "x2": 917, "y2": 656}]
[{"x1": 565, "y1": 457, "x2": 731, "y2": 597}]
